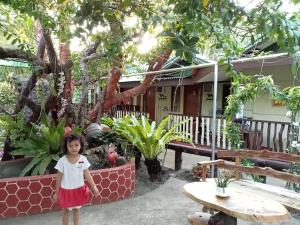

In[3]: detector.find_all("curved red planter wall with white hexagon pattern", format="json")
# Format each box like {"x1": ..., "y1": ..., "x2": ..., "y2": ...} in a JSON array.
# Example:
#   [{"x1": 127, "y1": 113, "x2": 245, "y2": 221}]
[{"x1": 0, "y1": 162, "x2": 135, "y2": 218}]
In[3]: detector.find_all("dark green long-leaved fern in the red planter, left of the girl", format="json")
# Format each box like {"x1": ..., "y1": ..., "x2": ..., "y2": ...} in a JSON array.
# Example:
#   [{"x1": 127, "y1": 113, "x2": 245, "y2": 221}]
[{"x1": 11, "y1": 116, "x2": 65, "y2": 176}]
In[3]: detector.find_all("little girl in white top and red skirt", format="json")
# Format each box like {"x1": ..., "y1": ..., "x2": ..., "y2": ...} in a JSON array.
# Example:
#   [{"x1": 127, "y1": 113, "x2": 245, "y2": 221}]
[{"x1": 53, "y1": 134, "x2": 99, "y2": 225}]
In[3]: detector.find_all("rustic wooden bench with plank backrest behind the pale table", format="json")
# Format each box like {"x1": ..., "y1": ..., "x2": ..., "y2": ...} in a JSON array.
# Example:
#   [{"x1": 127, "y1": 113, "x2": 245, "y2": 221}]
[{"x1": 198, "y1": 150, "x2": 300, "y2": 212}]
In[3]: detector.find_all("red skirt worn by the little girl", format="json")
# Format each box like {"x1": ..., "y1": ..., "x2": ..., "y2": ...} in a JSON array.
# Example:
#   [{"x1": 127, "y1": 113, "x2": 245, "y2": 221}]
[{"x1": 58, "y1": 185, "x2": 89, "y2": 208}]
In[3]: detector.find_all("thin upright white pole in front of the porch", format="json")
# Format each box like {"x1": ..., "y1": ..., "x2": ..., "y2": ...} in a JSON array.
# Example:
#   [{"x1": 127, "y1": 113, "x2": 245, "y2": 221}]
[{"x1": 211, "y1": 62, "x2": 218, "y2": 177}]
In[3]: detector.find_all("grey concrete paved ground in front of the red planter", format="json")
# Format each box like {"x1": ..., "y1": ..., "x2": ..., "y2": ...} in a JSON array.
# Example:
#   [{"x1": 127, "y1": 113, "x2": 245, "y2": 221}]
[{"x1": 0, "y1": 177, "x2": 300, "y2": 225}]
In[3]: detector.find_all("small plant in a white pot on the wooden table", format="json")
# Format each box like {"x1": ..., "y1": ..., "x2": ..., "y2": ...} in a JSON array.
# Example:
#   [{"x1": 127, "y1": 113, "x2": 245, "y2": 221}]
[{"x1": 215, "y1": 170, "x2": 233, "y2": 198}]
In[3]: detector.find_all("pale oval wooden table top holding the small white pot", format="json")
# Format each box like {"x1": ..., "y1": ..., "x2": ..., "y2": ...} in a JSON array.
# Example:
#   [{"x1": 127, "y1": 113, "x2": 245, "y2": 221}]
[{"x1": 183, "y1": 179, "x2": 290, "y2": 223}]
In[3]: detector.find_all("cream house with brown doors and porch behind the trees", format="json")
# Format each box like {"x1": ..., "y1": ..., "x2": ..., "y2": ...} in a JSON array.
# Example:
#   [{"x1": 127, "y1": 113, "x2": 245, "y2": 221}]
[{"x1": 120, "y1": 42, "x2": 293, "y2": 151}]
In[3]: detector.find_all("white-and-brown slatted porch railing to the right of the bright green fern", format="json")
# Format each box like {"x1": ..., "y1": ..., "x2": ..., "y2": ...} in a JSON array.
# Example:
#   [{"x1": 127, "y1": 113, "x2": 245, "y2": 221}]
[{"x1": 169, "y1": 114, "x2": 290, "y2": 152}]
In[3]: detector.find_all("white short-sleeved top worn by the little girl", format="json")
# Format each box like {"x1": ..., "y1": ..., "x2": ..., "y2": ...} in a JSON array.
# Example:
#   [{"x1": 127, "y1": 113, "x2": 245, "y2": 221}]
[{"x1": 55, "y1": 155, "x2": 91, "y2": 189}]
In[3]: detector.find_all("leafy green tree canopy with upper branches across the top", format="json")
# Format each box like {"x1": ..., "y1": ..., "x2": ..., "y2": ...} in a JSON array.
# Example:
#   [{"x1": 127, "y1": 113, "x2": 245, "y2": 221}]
[{"x1": 0, "y1": 0, "x2": 300, "y2": 123}]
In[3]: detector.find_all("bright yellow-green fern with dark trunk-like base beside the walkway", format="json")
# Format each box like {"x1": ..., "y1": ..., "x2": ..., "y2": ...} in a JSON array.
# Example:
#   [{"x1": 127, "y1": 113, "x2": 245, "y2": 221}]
[{"x1": 105, "y1": 116, "x2": 191, "y2": 181}]
